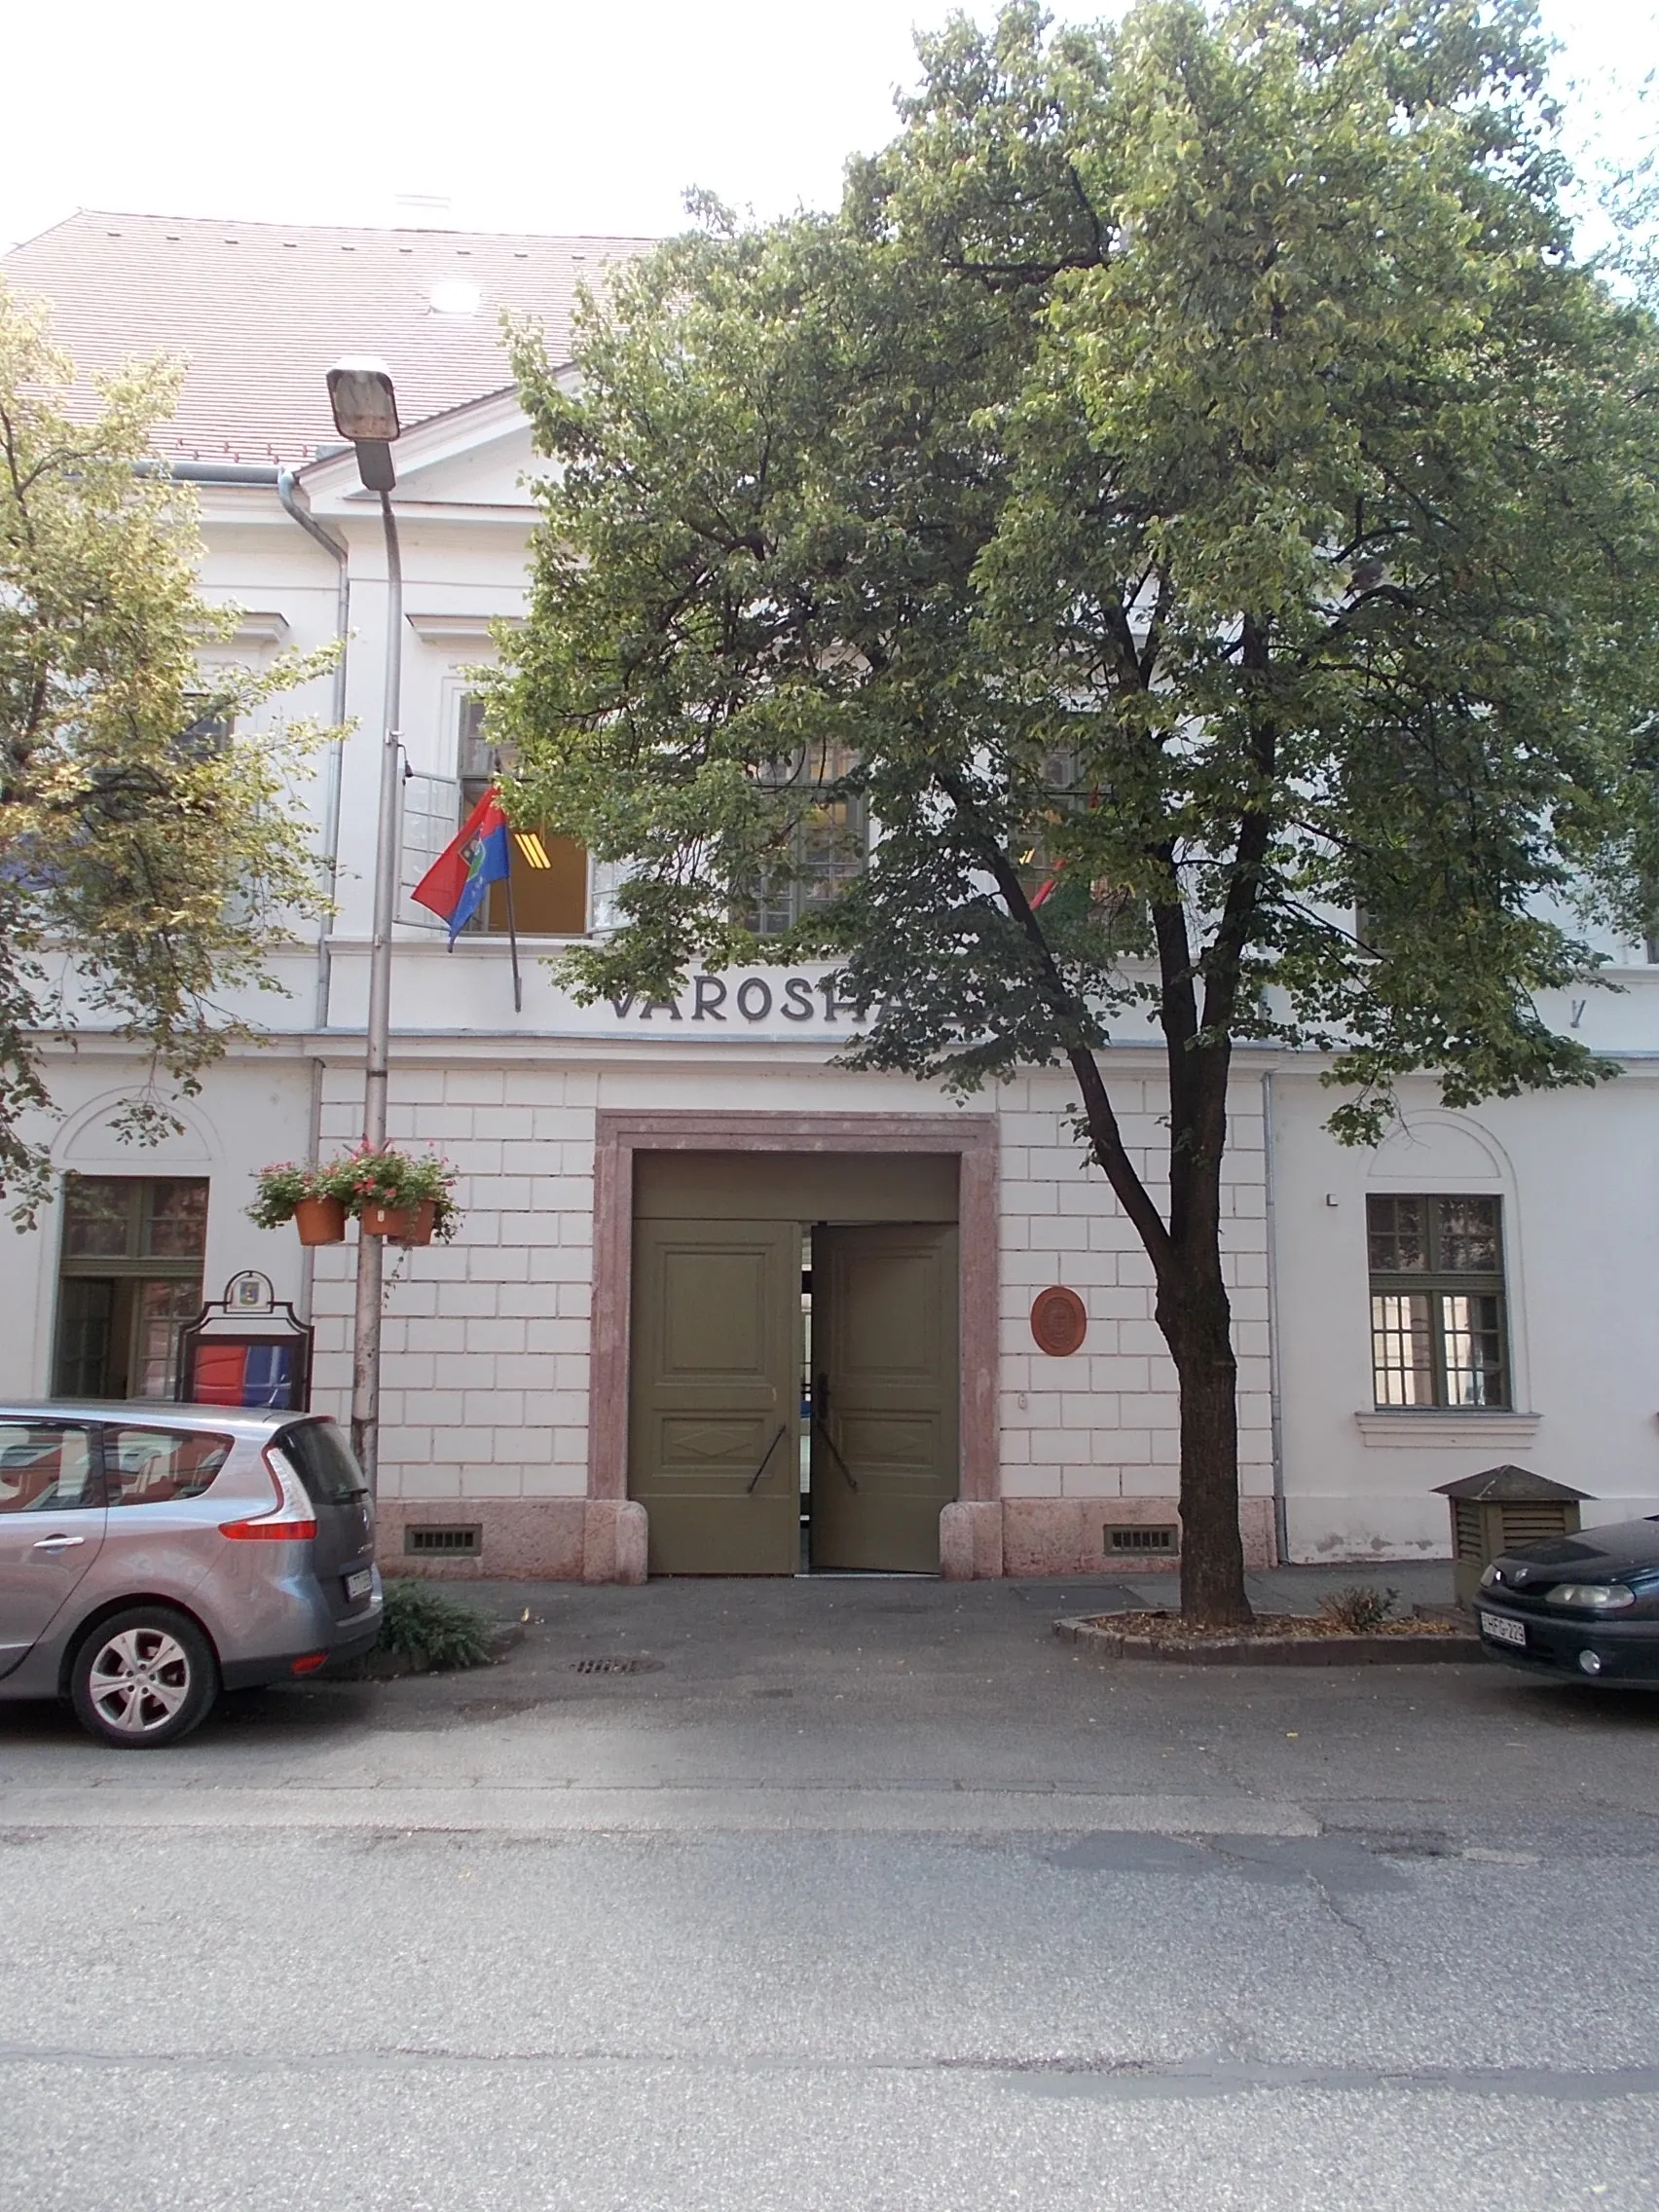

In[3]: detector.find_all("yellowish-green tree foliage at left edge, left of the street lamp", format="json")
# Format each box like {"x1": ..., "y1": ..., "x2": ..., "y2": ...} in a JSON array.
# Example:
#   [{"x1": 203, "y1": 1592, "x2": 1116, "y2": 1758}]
[{"x1": 0, "y1": 287, "x2": 323, "y2": 1221}]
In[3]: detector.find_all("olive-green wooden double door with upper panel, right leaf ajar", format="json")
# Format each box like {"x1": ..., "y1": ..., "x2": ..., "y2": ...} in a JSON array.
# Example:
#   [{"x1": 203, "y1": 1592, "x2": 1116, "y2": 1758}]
[{"x1": 628, "y1": 1155, "x2": 958, "y2": 1575}]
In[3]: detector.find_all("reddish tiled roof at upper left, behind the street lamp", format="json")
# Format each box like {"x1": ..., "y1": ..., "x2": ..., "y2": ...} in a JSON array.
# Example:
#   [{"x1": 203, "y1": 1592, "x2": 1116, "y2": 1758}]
[{"x1": 0, "y1": 208, "x2": 655, "y2": 466}]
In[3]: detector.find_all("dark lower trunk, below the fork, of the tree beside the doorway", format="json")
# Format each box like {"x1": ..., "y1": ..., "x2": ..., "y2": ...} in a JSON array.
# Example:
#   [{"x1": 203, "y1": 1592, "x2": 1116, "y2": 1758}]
[{"x1": 1157, "y1": 1250, "x2": 1252, "y2": 1628}]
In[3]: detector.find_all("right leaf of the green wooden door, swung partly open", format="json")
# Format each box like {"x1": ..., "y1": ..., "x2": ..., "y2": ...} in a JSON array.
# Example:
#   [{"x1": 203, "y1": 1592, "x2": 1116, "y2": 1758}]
[{"x1": 812, "y1": 1223, "x2": 958, "y2": 1575}]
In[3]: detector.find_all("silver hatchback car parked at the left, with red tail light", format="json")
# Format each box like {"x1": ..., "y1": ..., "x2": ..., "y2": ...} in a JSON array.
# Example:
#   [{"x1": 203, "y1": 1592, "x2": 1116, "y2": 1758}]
[{"x1": 0, "y1": 1398, "x2": 383, "y2": 1748}]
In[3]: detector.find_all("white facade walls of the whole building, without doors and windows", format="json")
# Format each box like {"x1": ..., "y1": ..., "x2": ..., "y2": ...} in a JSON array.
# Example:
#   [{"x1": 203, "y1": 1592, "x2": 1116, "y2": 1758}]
[{"x1": 0, "y1": 403, "x2": 1659, "y2": 1560}]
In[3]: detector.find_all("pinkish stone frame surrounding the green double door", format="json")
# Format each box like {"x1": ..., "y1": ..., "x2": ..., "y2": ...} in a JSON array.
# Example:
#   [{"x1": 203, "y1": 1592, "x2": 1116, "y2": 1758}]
[{"x1": 588, "y1": 1108, "x2": 1002, "y2": 1575}]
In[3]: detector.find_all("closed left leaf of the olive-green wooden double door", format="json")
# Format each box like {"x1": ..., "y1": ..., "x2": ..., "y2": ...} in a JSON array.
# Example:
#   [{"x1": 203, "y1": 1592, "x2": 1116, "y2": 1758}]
[{"x1": 628, "y1": 1221, "x2": 800, "y2": 1575}]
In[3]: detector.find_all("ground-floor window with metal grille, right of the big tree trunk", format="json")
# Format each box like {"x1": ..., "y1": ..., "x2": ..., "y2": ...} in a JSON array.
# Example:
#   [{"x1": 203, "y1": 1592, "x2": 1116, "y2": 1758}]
[{"x1": 1365, "y1": 1193, "x2": 1509, "y2": 1407}]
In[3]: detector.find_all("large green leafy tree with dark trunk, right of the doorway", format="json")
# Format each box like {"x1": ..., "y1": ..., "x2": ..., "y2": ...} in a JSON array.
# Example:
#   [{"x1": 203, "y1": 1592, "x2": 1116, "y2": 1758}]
[{"x1": 494, "y1": 0, "x2": 1659, "y2": 1621}]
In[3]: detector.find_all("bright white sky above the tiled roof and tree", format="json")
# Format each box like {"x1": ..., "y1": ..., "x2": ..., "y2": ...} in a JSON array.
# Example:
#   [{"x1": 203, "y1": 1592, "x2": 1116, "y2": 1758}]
[{"x1": 0, "y1": 0, "x2": 1659, "y2": 245}]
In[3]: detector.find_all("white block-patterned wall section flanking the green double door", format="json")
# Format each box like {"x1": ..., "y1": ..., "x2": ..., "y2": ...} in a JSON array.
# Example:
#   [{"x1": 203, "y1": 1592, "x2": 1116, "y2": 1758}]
[{"x1": 298, "y1": 1040, "x2": 1272, "y2": 1539}]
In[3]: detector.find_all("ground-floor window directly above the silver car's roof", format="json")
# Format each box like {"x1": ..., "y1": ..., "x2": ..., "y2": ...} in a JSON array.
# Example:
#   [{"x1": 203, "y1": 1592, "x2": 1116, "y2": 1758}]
[{"x1": 54, "y1": 1174, "x2": 208, "y2": 1398}]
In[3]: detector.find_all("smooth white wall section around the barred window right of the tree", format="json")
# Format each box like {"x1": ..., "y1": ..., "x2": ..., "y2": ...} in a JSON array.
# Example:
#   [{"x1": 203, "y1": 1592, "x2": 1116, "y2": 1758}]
[{"x1": 1272, "y1": 1062, "x2": 1659, "y2": 1560}]
